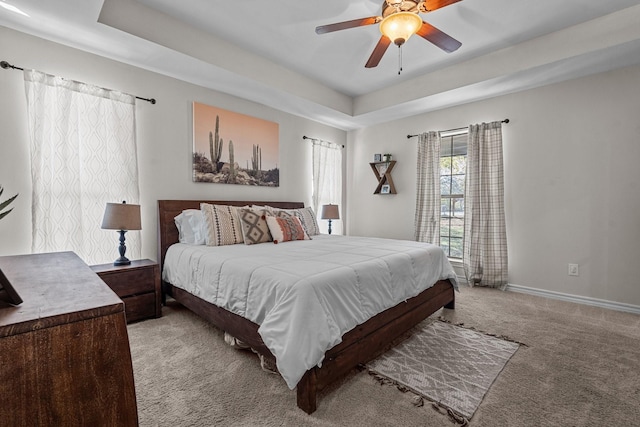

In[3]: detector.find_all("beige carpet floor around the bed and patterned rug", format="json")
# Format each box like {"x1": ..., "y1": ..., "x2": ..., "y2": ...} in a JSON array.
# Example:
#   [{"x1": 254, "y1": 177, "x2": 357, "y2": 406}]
[{"x1": 129, "y1": 287, "x2": 640, "y2": 427}]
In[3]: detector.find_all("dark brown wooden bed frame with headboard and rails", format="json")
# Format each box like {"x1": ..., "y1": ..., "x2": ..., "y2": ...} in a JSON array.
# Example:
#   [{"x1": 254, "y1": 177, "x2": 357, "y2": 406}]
[{"x1": 158, "y1": 200, "x2": 455, "y2": 414}]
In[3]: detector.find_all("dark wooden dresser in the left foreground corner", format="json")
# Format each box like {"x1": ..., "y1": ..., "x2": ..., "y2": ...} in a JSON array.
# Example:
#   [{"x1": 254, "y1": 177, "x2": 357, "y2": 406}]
[{"x1": 0, "y1": 252, "x2": 138, "y2": 426}]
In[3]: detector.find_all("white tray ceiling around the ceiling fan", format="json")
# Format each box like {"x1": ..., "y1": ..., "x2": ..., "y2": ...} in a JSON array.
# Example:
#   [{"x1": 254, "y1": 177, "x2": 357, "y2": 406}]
[{"x1": 0, "y1": 0, "x2": 640, "y2": 129}]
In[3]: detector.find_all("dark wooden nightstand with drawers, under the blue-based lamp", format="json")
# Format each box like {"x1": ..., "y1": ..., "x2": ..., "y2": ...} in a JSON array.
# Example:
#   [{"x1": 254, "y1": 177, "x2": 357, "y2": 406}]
[{"x1": 91, "y1": 259, "x2": 162, "y2": 323}]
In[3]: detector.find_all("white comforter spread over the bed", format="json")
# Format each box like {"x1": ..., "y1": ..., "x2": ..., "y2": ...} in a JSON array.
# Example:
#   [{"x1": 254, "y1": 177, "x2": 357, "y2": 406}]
[{"x1": 162, "y1": 235, "x2": 457, "y2": 389}]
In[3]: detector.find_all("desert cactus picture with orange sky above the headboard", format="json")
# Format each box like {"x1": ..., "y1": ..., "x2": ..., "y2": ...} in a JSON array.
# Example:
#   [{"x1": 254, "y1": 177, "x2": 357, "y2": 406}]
[{"x1": 193, "y1": 102, "x2": 280, "y2": 187}]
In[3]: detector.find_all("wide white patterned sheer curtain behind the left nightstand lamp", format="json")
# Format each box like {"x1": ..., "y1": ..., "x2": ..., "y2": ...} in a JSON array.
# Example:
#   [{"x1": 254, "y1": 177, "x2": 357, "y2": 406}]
[{"x1": 24, "y1": 70, "x2": 141, "y2": 264}]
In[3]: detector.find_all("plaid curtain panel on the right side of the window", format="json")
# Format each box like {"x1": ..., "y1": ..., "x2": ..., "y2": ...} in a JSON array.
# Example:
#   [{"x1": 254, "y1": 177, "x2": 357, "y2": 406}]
[{"x1": 463, "y1": 122, "x2": 508, "y2": 287}]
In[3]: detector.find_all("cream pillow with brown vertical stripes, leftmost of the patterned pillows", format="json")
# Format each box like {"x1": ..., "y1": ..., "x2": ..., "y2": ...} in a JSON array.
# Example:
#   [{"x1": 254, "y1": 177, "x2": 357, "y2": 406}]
[{"x1": 200, "y1": 203, "x2": 244, "y2": 246}]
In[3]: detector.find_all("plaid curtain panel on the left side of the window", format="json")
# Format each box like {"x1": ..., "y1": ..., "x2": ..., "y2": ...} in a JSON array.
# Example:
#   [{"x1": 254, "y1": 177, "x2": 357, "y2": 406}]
[{"x1": 415, "y1": 131, "x2": 440, "y2": 245}]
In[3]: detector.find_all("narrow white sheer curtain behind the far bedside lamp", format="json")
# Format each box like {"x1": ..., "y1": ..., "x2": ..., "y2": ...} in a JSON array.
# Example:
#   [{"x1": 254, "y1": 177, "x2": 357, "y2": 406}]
[{"x1": 312, "y1": 140, "x2": 343, "y2": 234}]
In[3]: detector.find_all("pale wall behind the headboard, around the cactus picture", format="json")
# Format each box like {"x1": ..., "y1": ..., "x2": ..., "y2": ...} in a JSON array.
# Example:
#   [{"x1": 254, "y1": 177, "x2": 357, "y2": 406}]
[{"x1": 0, "y1": 27, "x2": 346, "y2": 262}]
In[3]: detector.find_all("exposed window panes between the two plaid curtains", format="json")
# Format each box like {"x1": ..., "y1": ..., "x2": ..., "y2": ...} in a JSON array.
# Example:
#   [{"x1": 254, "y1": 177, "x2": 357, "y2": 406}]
[{"x1": 440, "y1": 129, "x2": 468, "y2": 259}]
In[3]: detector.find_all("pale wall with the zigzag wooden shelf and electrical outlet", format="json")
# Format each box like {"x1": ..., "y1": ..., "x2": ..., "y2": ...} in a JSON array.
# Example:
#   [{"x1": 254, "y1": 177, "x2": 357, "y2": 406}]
[{"x1": 348, "y1": 66, "x2": 640, "y2": 305}]
